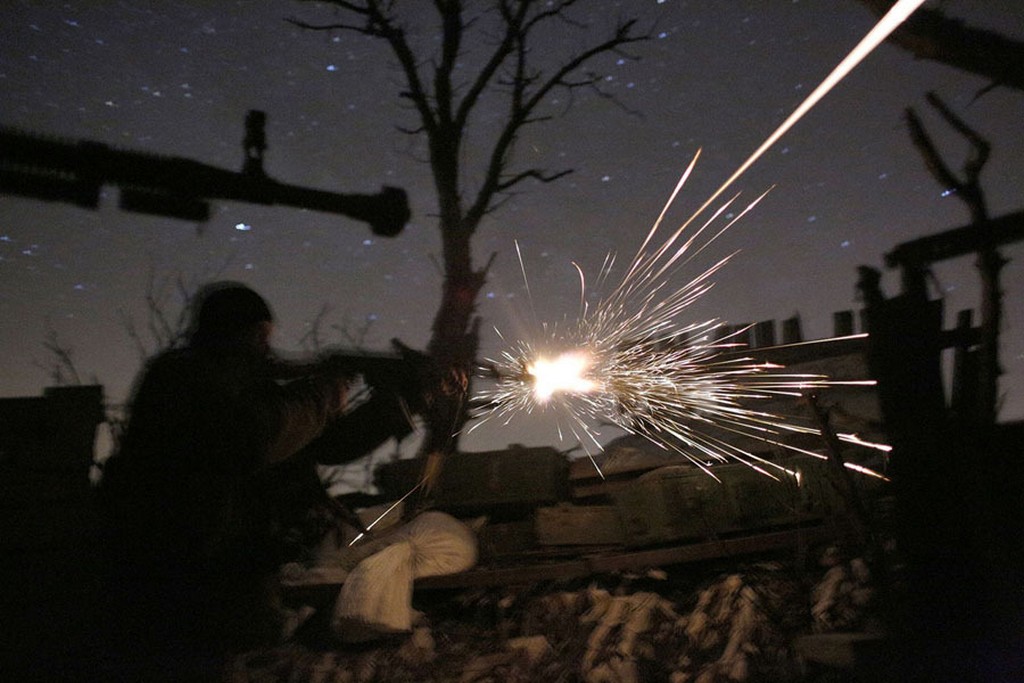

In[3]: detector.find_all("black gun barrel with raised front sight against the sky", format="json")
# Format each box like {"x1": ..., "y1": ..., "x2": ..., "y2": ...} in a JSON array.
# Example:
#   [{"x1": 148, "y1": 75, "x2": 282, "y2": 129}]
[{"x1": 0, "y1": 111, "x2": 411, "y2": 237}]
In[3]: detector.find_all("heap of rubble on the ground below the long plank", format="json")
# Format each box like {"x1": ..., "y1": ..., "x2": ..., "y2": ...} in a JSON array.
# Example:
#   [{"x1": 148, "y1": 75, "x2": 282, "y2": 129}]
[{"x1": 230, "y1": 560, "x2": 869, "y2": 683}]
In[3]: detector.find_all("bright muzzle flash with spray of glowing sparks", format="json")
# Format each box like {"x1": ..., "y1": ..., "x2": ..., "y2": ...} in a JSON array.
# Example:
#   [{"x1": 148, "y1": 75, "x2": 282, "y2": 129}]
[{"x1": 474, "y1": 154, "x2": 872, "y2": 476}]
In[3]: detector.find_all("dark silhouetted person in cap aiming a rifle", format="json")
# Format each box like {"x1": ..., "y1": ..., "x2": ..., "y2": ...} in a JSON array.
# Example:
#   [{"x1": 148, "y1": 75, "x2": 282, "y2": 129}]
[{"x1": 99, "y1": 283, "x2": 411, "y2": 680}]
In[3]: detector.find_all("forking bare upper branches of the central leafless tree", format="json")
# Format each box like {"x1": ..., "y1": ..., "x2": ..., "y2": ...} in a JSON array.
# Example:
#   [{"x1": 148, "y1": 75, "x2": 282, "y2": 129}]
[{"x1": 290, "y1": 0, "x2": 648, "y2": 231}]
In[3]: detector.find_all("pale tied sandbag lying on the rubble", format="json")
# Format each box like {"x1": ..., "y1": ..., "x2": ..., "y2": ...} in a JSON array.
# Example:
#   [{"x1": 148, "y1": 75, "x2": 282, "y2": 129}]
[{"x1": 332, "y1": 511, "x2": 477, "y2": 642}]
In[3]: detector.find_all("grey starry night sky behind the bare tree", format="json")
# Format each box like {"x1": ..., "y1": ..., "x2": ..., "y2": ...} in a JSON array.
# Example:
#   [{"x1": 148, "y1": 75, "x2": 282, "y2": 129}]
[{"x1": 0, "y1": 0, "x2": 1024, "y2": 458}]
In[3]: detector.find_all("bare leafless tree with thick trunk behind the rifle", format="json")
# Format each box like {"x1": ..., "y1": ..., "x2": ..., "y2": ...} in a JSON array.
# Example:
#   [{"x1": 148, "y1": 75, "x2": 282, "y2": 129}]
[{"x1": 292, "y1": 0, "x2": 646, "y2": 455}]
